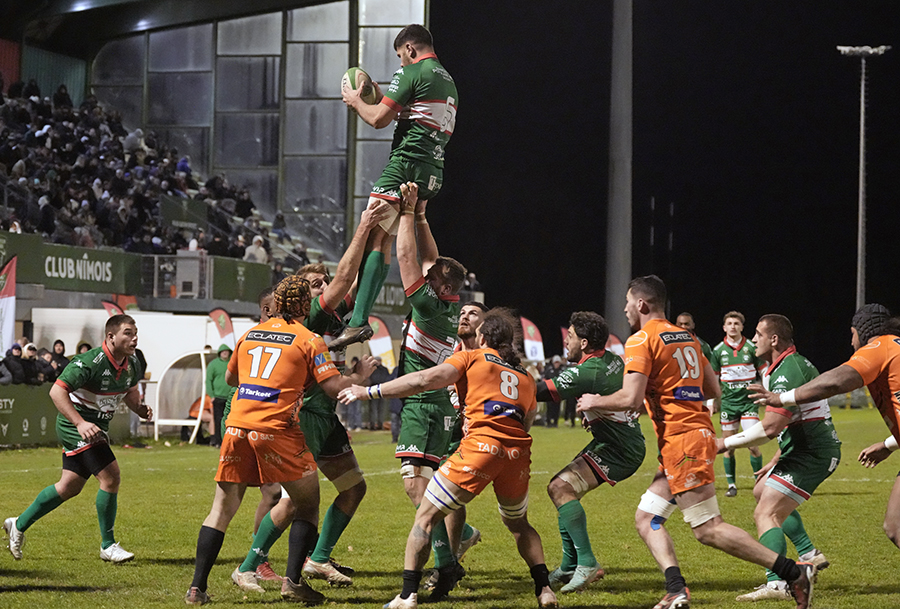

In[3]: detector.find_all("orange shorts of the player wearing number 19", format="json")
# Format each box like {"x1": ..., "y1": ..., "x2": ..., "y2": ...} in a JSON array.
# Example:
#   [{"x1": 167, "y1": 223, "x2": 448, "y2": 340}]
[{"x1": 659, "y1": 429, "x2": 716, "y2": 495}]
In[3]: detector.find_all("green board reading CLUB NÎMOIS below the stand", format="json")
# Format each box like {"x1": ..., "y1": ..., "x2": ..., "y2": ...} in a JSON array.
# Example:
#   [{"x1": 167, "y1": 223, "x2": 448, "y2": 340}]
[{"x1": 0, "y1": 233, "x2": 141, "y2": 294}]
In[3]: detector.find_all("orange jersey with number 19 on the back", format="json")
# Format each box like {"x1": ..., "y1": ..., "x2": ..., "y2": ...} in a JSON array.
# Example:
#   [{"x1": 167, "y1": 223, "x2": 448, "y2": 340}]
[{"x1": 625, "y1": 319, "x2": 713, "y2": 439}]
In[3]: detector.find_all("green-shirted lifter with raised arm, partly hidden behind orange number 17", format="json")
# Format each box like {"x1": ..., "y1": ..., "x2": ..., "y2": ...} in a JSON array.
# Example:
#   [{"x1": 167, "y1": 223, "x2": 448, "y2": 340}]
[{"x1": 233, "y1": 200, "x2": 388, "y2": 592}]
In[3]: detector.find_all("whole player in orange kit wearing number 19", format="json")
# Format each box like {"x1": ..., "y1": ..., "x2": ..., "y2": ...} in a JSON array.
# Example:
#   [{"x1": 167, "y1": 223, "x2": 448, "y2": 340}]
[{"x1": 578, "y1": 275, "x2": 815, "y2": 609}]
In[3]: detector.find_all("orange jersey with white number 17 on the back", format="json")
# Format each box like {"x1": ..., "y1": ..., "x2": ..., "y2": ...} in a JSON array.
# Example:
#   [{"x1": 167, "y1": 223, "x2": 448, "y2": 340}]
[{"x1": 225, "y1": 317, "x2": 340, "y2": 431}]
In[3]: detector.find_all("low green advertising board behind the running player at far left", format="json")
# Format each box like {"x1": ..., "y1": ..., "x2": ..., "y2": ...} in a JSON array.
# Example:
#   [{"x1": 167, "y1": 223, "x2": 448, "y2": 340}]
[{"x1": 0, "y1": 383, "x2": 130, "y2": 446}]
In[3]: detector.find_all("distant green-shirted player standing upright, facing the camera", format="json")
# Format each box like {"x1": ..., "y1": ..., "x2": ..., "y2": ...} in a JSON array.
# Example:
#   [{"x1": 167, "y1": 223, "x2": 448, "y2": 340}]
[{"x1": 709, "y1": 311, "x2": 762, "y2": 497}]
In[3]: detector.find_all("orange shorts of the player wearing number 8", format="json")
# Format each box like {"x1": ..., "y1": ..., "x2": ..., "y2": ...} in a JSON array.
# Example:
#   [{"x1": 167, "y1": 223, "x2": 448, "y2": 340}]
[{"x1": 439, "y1": 436, "x2": 531, "y2": 499}]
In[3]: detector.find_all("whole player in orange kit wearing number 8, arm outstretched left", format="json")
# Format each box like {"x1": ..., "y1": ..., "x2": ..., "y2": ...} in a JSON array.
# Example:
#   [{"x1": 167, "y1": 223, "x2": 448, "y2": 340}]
[{"x1": 338, "y1": 309, "x2": 558, "y2": 609}]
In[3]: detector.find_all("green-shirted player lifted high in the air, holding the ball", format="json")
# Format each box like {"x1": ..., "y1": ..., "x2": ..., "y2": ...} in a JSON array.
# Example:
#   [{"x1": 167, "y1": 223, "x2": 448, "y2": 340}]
[{"x1": 333, "y1": 24, "x2": 459, "y2": 349}]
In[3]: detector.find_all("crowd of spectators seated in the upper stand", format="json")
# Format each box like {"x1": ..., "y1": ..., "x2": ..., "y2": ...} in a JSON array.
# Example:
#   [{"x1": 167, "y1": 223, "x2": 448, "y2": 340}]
[{"x1": 0, "y1": 79, "x2": 308, "y2": 266}]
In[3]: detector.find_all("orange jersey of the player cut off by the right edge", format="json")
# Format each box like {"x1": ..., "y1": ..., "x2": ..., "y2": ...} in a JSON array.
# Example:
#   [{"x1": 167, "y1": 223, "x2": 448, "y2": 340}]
[{"x1": 844, "y1": 334, "x2": 900, "y2": 441}]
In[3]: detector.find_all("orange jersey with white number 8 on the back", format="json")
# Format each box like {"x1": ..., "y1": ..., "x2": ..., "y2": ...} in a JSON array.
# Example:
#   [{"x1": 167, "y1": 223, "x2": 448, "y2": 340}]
[{"x1": 444, "y1": 349, "x2": 537, "y2": 442}]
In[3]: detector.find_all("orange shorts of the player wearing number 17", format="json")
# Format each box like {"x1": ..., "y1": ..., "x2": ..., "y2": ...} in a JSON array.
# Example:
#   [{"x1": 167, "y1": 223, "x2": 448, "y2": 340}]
[{"x1": 216, "y1": 426, "x2": 316, "y2": 486}]
